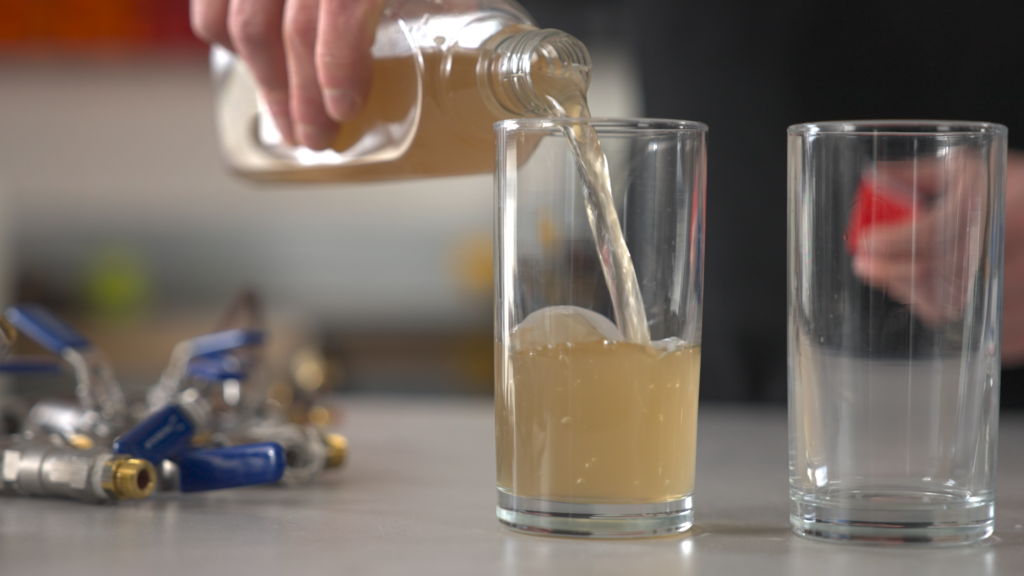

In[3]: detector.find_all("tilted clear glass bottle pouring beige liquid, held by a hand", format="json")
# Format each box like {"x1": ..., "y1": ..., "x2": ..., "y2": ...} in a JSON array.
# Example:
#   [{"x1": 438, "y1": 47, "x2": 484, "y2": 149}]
[{"x1": 211, "y1": 0, "x2": 590, "y2": 181}]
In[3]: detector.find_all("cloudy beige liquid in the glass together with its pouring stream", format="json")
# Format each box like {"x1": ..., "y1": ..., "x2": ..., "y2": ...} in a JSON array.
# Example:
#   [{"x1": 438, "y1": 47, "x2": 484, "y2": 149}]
[{"x1": 496, "y1": 40, "x2": 700, "y2": 503}]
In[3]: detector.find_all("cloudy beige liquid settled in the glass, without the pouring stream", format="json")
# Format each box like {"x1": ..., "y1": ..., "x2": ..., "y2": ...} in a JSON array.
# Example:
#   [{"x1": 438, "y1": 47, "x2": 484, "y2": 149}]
[{"x1": 496, "y1": 341, "x2": 700, "y2": 503}]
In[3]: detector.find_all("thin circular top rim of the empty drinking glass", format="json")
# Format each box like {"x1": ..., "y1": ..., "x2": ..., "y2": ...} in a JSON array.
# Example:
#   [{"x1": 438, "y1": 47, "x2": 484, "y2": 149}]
[{"x1": 786, "y1": 120, "x2": 1008, "y2": 136}]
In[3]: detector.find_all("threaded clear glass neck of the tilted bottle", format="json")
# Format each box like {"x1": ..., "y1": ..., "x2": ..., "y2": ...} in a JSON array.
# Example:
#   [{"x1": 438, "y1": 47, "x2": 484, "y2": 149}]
[{"x1": 476, "y1": 28, "x2": 591, "y2": 118}]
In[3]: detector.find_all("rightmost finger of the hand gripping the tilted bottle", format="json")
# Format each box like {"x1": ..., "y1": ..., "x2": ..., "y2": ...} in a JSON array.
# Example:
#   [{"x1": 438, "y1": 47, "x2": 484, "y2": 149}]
[{"x1": 316, "y1": 0, "x2": 383, "y2": 121}]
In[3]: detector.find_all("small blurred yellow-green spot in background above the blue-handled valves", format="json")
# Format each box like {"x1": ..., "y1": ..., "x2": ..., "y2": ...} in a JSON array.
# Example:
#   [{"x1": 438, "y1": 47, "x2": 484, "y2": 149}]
[{"x1": 85, "y1": 244, "x2": 154, "y2": 321}]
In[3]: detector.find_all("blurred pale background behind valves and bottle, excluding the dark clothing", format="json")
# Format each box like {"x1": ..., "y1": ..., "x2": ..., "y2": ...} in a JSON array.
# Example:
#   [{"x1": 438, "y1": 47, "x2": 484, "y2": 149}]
[{"x1": 0, "y1": 0, "x2": 643, "y2": 394}]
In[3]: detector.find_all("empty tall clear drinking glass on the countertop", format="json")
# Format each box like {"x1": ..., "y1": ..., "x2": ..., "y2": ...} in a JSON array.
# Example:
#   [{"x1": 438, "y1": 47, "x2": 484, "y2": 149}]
[{"x1": 788, "y1": 121, "x2": 1007, "y2": 543}]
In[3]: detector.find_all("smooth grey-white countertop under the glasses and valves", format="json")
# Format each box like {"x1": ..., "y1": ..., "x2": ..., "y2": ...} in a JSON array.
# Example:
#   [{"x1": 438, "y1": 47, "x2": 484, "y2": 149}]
[{"x1": 0, "y1": 398, "x2": 1024, "y2": 576}]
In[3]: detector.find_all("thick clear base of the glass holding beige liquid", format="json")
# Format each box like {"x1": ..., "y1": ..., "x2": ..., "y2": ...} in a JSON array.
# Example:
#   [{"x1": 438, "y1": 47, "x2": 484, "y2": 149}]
[{"x1": 498, "y1": 488, "x2": 693, "y2": 538}]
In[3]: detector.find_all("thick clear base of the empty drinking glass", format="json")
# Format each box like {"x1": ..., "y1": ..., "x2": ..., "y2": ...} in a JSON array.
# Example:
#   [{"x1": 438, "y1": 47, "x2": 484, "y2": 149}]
[{"x1": 790, "y1": 490, "x2": 994, "y2": 545}]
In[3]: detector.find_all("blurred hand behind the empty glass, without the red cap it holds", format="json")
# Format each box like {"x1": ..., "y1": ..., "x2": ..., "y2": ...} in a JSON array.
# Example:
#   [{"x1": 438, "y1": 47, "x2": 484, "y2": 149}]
[{"x1": 850, "y1": 152, "x2": 1024, "y2": 366}]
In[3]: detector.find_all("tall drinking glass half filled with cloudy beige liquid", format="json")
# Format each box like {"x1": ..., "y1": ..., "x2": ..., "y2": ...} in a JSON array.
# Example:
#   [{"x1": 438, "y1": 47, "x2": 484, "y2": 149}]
[{"x1": 495, "y1": 119, "x2": 707, "y2": 537}]
